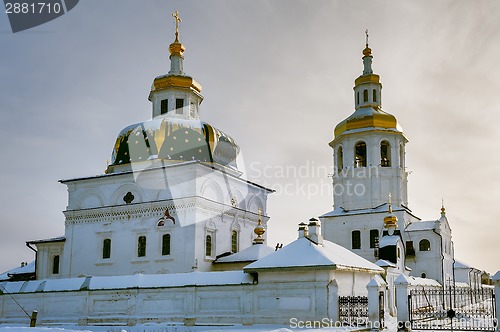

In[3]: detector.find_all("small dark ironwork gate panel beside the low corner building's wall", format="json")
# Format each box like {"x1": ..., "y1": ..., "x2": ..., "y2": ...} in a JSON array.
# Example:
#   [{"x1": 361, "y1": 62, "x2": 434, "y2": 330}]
[{"x1": 339, "y1": 296, "x2": 368, "y2": 326}]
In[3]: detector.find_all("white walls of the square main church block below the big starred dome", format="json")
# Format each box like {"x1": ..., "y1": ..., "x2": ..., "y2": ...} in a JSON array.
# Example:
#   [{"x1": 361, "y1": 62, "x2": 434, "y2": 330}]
[{"x1": 52, "y1": 163, "x2": 269, "y2": 278}]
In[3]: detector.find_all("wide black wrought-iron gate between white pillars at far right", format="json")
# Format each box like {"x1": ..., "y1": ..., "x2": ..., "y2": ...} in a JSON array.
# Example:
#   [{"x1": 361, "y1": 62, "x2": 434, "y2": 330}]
[{"x1": 408, "y1": 287, "x2": 498, "y2": 331}]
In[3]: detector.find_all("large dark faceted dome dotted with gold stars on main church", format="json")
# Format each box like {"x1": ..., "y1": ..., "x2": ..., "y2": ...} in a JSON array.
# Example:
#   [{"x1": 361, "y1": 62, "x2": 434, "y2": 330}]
[{"x1": 107, "y1": 116, "x2": 239, "y2": 173}]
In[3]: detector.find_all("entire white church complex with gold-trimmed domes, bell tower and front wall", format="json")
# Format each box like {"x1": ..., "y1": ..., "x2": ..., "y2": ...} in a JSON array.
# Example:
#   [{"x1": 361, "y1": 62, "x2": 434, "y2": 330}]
[{"x1": 0, "y1": 12, "x2": 494, "y2": 326}]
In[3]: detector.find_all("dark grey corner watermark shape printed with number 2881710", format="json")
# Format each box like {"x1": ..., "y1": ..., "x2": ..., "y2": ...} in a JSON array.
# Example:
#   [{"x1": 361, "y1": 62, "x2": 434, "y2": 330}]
[{"x1": 4, "y1": 0, "x2": 80, "y2": 33}]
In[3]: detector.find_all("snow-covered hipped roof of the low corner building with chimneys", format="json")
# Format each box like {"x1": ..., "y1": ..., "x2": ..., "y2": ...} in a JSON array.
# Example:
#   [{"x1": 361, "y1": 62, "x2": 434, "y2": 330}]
[{"x1": 243, "y1": 237, "x2": 383, "y2": 272}]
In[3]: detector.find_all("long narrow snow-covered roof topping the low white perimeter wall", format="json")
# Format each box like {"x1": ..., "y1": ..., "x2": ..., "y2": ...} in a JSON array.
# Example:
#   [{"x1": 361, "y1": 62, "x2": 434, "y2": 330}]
[{"x1": 0, "y1": 271, "x2": 253, "y2": 293}]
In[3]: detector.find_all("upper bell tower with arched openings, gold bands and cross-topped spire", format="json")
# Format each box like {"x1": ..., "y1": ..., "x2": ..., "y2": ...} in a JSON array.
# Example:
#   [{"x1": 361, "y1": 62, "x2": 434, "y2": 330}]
[{"x1": 330, "y1": 31, "x2": 408, "y2": 210}]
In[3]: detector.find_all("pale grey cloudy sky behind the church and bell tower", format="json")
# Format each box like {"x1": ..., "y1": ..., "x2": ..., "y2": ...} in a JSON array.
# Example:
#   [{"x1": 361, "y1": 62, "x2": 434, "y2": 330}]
[{"x1": 0, "y1": 0, "x2": 500, "y2": 273}]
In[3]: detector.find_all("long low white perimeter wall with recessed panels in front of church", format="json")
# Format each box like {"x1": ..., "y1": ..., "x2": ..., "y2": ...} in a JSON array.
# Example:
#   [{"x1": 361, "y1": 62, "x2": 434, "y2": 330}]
[{"x1": 0, "y1": 271, "x2": 371, "y2": 326}]
